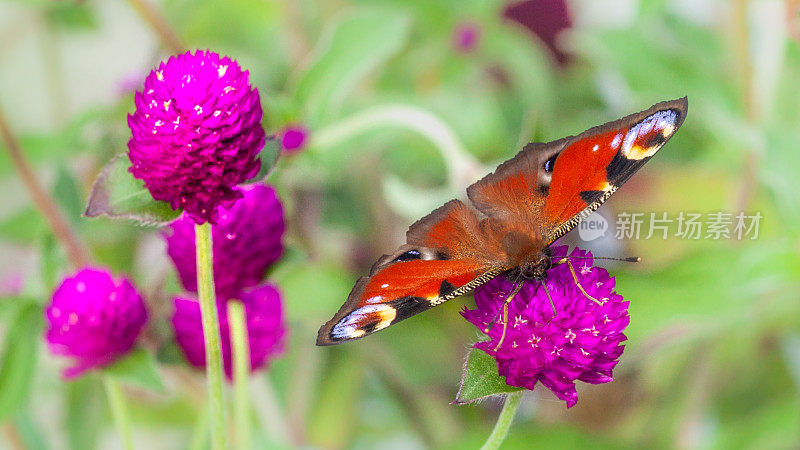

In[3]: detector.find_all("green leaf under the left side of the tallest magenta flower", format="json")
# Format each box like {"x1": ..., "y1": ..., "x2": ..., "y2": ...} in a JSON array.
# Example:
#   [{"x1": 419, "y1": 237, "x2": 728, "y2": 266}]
[{"x1": 83, "y1": 154, "x2": 180, "y2": 225}]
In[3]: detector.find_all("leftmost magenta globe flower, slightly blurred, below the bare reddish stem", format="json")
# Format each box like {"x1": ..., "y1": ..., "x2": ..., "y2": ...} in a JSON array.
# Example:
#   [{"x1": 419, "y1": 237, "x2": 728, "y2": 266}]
[{"x1": 45, "y1": 268, "x2": 147, "y2": 378}]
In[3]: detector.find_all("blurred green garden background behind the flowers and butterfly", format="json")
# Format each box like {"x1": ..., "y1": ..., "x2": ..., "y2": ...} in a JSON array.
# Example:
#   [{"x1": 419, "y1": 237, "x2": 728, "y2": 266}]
[{"x1": 0, "y1": 0, "x2": 800, "y2": 449}]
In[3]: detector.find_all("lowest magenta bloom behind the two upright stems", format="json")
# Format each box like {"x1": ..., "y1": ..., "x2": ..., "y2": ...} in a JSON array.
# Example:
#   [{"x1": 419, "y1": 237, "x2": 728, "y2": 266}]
[{"x1": 172, "y1": 284, "x2": 286, "y2": 379}]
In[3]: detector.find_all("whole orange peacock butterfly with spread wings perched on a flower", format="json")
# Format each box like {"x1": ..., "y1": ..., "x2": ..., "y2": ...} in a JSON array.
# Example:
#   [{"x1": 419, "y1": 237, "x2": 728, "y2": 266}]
[{"x1": 317, "y1": 97, "x2": 688, "y2": 345}]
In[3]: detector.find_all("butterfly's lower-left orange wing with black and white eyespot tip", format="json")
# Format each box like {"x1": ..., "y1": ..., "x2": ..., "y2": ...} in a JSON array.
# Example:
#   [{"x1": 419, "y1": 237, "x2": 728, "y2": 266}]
[{"x1": 317, "y1": 200, "x2": 506, "y2": 345}]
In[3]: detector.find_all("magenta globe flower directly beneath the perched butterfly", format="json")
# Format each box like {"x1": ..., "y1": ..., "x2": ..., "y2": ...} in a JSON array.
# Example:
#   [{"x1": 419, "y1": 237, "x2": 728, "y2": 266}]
[{"x1": 461, "y1": 246, "x2": 630, "y2": 407}]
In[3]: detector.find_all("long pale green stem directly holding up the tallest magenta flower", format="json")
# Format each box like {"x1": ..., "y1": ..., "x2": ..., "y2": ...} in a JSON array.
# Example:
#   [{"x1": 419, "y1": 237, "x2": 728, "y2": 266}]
[{"x1": 194, "y1": 223, "x2": 228, "y2": 450}]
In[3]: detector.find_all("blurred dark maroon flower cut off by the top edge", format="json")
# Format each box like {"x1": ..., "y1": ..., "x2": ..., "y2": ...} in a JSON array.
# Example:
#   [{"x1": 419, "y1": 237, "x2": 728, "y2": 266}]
[{"x1": 503, "y1": 0, "x2": 572, "y2": 66}]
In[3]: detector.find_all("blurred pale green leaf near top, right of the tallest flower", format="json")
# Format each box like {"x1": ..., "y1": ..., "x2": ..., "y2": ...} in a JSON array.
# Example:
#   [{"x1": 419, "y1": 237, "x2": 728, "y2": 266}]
[{"x1": 296, "y1": 8, "x2": 411, "y2": 126}]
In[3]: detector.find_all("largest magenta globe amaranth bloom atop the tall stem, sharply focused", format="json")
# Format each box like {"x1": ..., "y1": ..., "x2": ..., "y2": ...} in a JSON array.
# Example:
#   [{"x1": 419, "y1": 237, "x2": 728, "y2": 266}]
[{"x1": 128, "y1": 50, "x2": 265, "y2": 223}]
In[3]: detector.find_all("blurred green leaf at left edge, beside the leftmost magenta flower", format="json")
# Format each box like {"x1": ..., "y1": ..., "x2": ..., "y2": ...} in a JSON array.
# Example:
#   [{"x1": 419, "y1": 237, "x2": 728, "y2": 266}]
[{"x1": 0, "y1": 305, "x2": 43, "y2": 422}]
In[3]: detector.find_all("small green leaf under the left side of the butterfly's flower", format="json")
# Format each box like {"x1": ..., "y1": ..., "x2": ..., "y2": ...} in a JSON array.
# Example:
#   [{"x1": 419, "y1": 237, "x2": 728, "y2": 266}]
[{"x1": 454, "y1": 348, "x2": 522, "y2": 405}]
